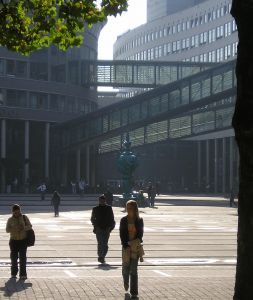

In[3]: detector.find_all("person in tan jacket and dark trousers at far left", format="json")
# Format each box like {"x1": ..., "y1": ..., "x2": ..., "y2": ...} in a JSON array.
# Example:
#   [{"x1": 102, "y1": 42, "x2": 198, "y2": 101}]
[{"x1": 6, "y1": 204, "x2": 32, "y2": 280}]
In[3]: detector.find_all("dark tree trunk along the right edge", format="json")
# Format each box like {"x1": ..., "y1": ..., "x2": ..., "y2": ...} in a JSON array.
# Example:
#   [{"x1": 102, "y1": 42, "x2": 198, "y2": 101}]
[{"x1": 231, "y1": 0, "x2": 253, "y2": 300}]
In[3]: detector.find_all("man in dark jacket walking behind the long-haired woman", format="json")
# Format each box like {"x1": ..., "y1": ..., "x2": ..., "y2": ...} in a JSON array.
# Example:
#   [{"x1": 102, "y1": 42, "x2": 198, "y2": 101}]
[{"x1": 91, "y1": 195, "x2": 115, "y2": 263}]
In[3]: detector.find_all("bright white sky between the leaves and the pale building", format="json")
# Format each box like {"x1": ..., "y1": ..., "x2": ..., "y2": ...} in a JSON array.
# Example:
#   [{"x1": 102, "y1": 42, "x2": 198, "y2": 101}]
[{"x1": 98, "y1": 0, "x2": 147, "y2": 59}]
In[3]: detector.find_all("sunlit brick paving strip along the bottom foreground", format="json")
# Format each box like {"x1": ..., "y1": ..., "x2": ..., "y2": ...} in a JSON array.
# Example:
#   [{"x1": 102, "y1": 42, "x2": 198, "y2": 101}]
[{"x1": 0, "y1": 277, "x2": 233, "y2": 300}]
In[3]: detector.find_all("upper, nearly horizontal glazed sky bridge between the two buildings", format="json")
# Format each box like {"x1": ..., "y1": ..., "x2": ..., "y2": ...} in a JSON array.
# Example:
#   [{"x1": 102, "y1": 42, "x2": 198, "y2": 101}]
[{"x1": 81, "y1": 60, "x2": 217, "y2": 88}]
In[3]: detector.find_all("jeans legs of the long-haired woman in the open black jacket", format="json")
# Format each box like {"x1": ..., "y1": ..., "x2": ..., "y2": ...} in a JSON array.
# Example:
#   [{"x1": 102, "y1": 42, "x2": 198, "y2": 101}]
[{"x1": 122, "y1": 258, "x2": 139, "y2": 295}]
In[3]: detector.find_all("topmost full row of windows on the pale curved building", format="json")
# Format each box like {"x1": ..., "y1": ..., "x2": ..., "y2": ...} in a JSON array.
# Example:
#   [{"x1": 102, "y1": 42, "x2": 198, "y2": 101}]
[{"x1": 114, "y1": 4, "x2": 235, "y2": 57}]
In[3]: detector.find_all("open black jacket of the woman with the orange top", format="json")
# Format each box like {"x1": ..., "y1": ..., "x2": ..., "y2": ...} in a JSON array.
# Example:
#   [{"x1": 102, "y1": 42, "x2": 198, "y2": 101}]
[{"x1": 119, "y1": 216, "x2": 144, "y2": 248}]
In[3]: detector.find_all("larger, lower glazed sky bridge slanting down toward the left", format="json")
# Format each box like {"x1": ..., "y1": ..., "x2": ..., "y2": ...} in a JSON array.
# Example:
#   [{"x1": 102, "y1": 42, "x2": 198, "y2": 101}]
[{"x1": 55, "y1": 60, "x2": 236, "y2": 152}]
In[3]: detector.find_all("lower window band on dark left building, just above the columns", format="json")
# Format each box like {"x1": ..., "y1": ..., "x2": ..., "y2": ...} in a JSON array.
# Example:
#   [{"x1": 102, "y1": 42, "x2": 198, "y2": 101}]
[{"x1": 0, "y1": 89, "x2": 96, "y2": 114}]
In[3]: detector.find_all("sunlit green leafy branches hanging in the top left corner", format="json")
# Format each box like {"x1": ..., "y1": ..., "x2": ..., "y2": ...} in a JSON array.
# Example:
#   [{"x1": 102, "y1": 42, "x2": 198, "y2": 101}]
[{"x1": 0, "y1": 0, "x2": 128, "y2": 55}]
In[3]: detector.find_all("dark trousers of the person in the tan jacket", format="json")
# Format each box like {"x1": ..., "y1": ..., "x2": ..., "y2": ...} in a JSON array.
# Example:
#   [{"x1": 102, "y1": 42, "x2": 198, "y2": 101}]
[{"x1": 9, "y1": 240, "x2": 27, "y2": 276}]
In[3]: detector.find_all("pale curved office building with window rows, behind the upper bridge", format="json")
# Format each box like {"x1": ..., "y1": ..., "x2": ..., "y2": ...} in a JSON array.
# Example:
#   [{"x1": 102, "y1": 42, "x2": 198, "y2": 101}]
[{"x1": 114, "y1": 0, "x2": 238, "y2": 62}]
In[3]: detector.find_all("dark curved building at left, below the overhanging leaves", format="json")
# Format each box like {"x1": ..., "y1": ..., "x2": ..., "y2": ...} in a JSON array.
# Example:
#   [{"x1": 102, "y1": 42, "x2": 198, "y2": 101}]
[{"x1": 0, "y1": 24, "x2": 103, "y2": 192}]
